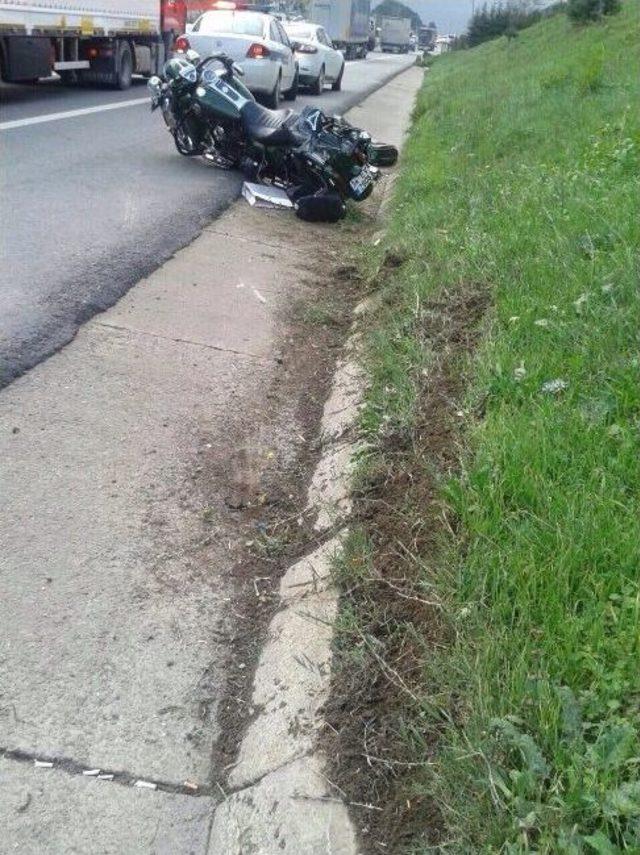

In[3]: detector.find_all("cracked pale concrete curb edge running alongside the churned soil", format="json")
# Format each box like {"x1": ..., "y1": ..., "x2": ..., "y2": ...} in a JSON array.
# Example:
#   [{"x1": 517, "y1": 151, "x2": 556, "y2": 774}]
[{"x1": 208, "y1": 63, "x2": 422, "y2": 855}]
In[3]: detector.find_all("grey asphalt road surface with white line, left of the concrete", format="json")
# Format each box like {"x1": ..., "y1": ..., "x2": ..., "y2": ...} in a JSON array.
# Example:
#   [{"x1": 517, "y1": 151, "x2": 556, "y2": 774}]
[{"x1": 0, "y1": 54, "x2": 413, "y2": 387}]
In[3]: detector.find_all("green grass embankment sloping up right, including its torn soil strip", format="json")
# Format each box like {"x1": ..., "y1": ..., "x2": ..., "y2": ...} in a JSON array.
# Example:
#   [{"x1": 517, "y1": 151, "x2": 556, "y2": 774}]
[{"x1": 334, "y1": 2, "x2": 640, "y2": 853}]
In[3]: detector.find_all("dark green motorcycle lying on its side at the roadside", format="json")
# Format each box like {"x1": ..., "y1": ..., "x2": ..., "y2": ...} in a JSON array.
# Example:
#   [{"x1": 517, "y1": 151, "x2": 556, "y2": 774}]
[{"x1": 148, "y1": 51, "x2": 398, "y2": 222}]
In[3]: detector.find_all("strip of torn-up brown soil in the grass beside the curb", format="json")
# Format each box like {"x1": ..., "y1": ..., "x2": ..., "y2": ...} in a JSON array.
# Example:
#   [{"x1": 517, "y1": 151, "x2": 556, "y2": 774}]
[{"x1": 325, "y1": 284, "x2": 488, "y2": 853}]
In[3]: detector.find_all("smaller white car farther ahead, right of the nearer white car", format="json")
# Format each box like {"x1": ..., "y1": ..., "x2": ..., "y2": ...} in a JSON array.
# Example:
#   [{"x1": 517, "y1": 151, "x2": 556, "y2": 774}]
[{"x1": 284, "y1": 21, "x2": 345, "y2": 95}]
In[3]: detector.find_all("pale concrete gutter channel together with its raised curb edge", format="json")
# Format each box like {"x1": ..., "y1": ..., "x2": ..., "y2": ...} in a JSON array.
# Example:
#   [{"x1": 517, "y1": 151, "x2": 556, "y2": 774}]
[{"x1": 0, "y1": 68, "x2": 422, "y2": 855}]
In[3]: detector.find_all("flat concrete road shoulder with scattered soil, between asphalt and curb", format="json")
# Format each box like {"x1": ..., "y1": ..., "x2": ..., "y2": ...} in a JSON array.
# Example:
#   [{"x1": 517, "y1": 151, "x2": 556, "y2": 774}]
[{"x1": 0, "y1": 63, "x2": 428, "y2": 853}]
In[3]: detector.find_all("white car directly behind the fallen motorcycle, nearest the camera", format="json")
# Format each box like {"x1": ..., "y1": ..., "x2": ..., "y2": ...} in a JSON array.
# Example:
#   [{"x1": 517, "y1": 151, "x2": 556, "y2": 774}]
[{"x1": 174, "y1": 4, "x2": 298, "y2": 110}]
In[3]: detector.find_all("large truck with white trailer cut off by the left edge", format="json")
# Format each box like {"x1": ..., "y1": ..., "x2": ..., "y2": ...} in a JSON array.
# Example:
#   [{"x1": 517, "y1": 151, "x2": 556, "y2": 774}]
[{"x1": 0, "y1": 0, "x2": 186, "y2": 89}]
